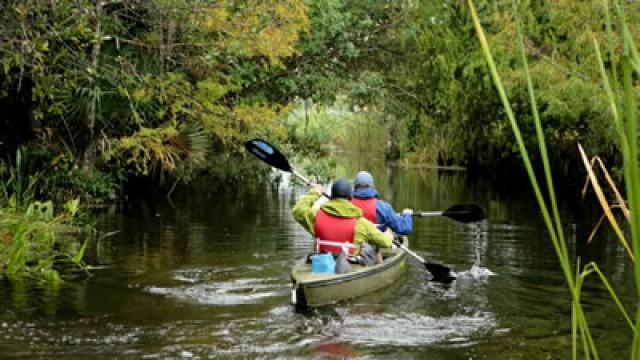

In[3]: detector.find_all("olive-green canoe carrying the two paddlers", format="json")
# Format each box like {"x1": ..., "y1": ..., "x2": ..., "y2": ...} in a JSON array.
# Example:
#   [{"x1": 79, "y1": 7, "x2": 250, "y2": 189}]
[{"x1": 291, "y1": 239, "x2": 407, "y2": 308}]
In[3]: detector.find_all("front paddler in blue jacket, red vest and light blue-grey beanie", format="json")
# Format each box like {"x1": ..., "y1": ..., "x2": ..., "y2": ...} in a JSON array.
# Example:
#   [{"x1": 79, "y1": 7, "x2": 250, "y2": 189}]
[{"x1": 351, "y1": 171, "x2": 413, "y2": 235}]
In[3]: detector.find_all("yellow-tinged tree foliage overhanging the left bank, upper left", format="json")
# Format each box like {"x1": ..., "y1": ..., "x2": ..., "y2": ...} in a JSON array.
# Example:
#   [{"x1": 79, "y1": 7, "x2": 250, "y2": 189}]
[{"x1": 0, "y1": 0, "x2": 308, "y2": 197}]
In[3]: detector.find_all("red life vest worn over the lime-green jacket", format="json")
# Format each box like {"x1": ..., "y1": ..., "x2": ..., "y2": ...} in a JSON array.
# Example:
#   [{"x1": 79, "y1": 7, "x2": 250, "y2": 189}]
[{"x1": 315, "y1": 209, "x2": 358, "y2": 255}]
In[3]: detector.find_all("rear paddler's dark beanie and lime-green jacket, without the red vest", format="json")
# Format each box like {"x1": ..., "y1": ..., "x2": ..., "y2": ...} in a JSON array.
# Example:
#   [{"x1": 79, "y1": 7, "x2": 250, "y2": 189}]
[{"x1": 291, "y1": 179, "x2": 393, "y2": 262}]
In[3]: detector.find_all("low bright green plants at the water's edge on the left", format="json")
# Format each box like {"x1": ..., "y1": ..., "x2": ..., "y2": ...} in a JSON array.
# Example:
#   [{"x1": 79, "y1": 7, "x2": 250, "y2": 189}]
[{"x1": 0, "y1": 200, "x2": 87, "y2": 284}]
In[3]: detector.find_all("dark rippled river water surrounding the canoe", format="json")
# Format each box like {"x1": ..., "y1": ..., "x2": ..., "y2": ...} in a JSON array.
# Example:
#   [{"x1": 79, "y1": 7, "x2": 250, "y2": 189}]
[{"x1": 0, "y1": 170, "x2": 633, "y2": 359}]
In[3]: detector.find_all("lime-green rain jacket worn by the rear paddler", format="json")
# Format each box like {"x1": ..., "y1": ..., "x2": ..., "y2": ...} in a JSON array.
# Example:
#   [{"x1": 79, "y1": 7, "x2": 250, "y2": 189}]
[{"x1": 291, "y1": 190, "x2": 391, "y2": 255}]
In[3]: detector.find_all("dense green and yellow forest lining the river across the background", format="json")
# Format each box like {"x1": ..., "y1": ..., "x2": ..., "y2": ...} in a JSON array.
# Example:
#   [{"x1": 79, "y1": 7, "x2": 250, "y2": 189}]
[{"x1": 0, "y1": 0, "x2": 640, "y2": 201}]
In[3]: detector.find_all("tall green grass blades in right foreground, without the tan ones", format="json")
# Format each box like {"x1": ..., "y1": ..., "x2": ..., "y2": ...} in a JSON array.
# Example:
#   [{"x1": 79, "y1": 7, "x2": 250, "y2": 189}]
[{"x1": 467, "y1": 0, "x2": 640, "y2": 359}]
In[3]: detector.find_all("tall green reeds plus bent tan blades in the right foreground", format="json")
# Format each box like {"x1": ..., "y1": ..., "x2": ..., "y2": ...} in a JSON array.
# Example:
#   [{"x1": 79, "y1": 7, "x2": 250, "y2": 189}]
[{"x1": 467, "y1": 0, "x2": 640, "y2": 359}]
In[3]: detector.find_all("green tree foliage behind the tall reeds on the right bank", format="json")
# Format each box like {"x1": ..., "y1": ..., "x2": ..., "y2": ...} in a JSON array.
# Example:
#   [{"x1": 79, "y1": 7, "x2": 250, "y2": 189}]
[{"x1": 376, "y1": 0, "x2": 640, "y2": 173}]
